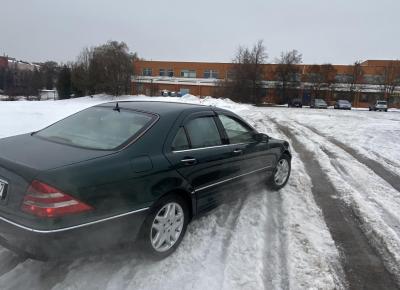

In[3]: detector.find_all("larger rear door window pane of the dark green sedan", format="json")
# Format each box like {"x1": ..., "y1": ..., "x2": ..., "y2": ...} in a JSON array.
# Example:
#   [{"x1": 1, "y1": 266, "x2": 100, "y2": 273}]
[{"x1": 185, "y1": 117, "x2": 222, "y2": 148}]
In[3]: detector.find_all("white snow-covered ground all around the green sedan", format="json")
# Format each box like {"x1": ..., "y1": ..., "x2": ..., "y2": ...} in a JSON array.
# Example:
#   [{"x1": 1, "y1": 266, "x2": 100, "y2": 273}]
[{"x1": 0, "y1": 95, "x2": 400, "y2": 289}]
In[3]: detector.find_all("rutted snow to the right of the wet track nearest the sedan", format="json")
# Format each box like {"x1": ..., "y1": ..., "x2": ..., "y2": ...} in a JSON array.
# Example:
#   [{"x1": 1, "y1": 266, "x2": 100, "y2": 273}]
[{"x1": 263, "y1": 109, "x2": 400, "y2": 281}]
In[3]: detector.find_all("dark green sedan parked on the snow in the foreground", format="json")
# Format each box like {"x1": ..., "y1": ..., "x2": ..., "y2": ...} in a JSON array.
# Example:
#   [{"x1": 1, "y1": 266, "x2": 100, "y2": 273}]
[{"x1": 0, "y1": 101, "x2": 291, "y2": 259}]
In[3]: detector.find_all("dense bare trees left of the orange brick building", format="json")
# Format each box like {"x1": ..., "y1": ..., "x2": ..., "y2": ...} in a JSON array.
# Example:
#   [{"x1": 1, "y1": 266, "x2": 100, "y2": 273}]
[{"x1": 0, "y1": 41, "x2": 137, "y2": 99}]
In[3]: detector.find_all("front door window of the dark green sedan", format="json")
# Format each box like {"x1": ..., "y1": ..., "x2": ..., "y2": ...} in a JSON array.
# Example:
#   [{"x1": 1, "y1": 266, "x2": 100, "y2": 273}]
[{"x1": 218, "y1": 115, "x2": 254, "y2": 144}]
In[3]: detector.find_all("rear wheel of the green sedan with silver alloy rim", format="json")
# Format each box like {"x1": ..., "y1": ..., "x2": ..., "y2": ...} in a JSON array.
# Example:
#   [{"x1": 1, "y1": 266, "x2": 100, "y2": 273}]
[{"x1": 138, "y1": 194, "x2": 190, "y2": 260}]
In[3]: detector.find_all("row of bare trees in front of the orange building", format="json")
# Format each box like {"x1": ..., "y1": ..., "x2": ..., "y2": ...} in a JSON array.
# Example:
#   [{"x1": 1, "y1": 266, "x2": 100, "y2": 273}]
[{"x1": 215, "y1": 40, "x2": 400, "y2": 104}]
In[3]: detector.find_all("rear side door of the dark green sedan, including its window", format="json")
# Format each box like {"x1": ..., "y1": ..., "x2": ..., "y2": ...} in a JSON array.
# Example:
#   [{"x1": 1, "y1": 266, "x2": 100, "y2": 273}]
[{"x1": 165, "y1": 110, "x2": 244, "y2": 212}]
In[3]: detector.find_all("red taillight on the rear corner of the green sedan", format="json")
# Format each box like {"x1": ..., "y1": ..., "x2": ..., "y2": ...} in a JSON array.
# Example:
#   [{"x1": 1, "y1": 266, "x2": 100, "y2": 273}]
[{"x1": 21, "y1": 180, "x2": 93, "y2": 217}]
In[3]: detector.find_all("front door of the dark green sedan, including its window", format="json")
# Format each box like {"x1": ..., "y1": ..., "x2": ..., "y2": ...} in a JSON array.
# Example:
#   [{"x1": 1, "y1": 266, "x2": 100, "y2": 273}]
[{"x1": 217, "y1": 111, "x2": 277, "y2": 182}]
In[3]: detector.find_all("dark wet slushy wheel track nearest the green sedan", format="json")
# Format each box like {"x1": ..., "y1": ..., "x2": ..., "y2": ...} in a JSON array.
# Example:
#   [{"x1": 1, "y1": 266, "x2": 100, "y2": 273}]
[{"x1": 271, "y1": 118, "x2": 399, "y2": 289}]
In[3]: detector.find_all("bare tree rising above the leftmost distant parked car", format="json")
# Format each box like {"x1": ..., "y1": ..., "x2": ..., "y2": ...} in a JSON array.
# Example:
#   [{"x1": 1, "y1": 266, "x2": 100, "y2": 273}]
[{"x1": 275, "y1": 49, "x2": 302, "y2": 102}]
